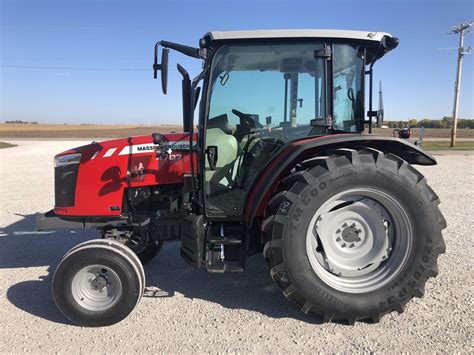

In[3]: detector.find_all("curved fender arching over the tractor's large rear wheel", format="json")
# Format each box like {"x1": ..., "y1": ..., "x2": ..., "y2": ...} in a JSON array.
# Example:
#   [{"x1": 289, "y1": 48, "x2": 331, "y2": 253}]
[{"x1": 245, "y1": 134, "x2": 436, "y2": 226}]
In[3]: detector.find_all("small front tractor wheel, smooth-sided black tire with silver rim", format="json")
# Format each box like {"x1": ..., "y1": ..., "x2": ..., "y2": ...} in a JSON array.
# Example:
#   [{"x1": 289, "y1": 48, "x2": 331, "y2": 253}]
[{"x1": 53, "y1": 240, "x2": 144, "y2": 327}]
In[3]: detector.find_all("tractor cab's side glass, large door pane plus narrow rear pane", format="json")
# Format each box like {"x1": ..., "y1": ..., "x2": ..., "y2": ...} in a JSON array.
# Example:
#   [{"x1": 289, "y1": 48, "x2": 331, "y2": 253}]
[{"x1": 205, "y1": 42, "x2": 363, "y2": 216}]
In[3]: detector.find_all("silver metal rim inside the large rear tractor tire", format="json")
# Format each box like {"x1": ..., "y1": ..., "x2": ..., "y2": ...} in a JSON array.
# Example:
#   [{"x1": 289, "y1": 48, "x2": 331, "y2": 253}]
[{"x1": 306, "y1": 188, "x2": 413, "y2": 293}]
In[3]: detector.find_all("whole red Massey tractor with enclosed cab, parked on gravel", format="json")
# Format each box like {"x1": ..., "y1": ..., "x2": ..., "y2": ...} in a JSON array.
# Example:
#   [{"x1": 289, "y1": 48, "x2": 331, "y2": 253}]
[{"x1": 37, "y1": 30, "x2": 446, "y2": 326}]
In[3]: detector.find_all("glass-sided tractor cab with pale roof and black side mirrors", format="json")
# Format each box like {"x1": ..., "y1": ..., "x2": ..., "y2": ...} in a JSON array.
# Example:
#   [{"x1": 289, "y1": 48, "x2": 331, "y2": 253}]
[{"x1": 154, "y1": 30, "x2": 398, "y2": 219}]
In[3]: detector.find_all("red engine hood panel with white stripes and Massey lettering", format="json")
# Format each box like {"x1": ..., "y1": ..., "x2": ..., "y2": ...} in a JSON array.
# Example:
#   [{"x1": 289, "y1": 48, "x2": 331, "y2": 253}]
[{"x1": 54, "y1": 133, "x2": 195, "y2": 216}]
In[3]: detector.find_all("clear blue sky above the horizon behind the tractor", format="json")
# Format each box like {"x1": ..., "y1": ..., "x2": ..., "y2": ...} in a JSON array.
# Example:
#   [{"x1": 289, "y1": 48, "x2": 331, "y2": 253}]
[{"x1": 0, "y1": 0, "x2": 474, "y2": 124}]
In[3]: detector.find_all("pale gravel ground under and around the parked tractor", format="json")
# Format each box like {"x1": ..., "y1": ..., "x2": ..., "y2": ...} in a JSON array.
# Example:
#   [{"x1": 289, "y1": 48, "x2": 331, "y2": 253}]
[{"x1": 0, "y1": 141, "x2": 474, "y2": 353}]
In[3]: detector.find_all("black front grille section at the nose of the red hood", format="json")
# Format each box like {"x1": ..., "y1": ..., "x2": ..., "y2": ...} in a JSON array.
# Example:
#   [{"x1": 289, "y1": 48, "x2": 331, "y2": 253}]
[{"x1": 54, "y1": 164, "x2": 79, "y2": 207}]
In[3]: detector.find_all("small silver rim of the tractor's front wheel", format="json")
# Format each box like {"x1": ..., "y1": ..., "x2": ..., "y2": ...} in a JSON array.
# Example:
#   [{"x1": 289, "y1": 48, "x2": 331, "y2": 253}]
[{"x1": 71, "y1": 265, "x2": 122, "y2": 311}]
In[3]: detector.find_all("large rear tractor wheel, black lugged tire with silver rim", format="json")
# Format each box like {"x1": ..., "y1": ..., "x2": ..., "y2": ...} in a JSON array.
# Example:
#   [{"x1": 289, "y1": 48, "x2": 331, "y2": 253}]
[{"x1": 264, "y1": 149, "x2": 446, "y2": 323}]
